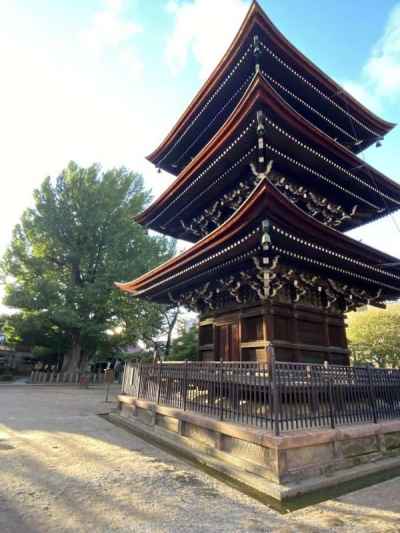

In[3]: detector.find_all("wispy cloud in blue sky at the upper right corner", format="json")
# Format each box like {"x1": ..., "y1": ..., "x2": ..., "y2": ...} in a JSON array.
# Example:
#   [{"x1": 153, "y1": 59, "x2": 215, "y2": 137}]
[{"x1": 343, "y1": 3, "x2": 400, "y2": 112}]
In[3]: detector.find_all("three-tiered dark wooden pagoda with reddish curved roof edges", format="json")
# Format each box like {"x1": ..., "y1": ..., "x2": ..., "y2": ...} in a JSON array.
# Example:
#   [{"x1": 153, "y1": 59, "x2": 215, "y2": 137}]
[{"x1": 117, "y1": 2, "x2": 400, "y2": 364}]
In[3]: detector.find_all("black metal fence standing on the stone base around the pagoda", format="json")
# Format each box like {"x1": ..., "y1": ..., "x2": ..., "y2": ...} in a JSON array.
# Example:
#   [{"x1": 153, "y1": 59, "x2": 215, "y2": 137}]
[{"x1": 122, "y1": 362, "x2": 400, "y2": 435}]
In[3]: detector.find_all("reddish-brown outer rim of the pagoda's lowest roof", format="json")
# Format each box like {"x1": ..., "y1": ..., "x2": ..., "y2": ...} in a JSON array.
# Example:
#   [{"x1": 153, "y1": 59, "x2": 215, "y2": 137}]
[{"x1": 116, "y1": 179, "x2": 400, "y2": 294}]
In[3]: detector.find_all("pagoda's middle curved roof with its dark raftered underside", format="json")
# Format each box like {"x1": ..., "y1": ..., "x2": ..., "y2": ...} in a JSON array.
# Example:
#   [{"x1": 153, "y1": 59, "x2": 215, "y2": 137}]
[{"x1": 136, "y1": 73, "x2": 400, "y2": 237}]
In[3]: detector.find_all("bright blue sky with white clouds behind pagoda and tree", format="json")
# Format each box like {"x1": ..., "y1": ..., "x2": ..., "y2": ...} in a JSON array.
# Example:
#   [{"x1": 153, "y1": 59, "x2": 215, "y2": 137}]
[{"x1": 0, "y1": 0, "x2": 400, "y2": 311}]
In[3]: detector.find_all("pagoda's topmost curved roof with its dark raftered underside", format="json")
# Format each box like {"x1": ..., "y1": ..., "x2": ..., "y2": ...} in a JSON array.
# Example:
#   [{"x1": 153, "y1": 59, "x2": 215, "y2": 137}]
[{"x1": 148, "y1": 2, "x2": 394, "y2": 175}]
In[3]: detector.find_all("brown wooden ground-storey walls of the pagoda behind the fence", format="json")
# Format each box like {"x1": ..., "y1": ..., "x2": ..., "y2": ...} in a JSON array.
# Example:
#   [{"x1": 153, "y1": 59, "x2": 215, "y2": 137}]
[{"x1": 200, "y1": 302, "x2": 349, "y2": 364}]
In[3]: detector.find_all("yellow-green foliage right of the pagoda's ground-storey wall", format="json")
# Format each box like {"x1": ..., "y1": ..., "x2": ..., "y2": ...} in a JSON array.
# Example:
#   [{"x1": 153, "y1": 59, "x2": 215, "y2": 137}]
[{"x1": 347, "y1": 304, "x2": 400, "y2": 368}]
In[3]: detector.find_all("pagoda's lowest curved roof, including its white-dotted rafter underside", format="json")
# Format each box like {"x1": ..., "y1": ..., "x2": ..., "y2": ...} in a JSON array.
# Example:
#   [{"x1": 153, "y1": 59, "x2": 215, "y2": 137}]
[{"x1": 116, "y1": 179, "x2": 400, "y2": 302}]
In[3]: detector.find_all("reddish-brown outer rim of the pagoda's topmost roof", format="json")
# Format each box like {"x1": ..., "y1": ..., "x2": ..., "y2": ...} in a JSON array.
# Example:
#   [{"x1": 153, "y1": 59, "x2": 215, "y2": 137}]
[{"x1": 146, "y1": 1, "x2": 396, "y2": 171}]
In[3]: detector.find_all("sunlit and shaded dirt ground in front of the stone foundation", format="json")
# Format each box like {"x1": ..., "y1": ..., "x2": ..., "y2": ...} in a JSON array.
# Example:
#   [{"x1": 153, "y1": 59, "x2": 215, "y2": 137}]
[{"x1": 0, "y1": 386, "x2": 400, "y2": 533}]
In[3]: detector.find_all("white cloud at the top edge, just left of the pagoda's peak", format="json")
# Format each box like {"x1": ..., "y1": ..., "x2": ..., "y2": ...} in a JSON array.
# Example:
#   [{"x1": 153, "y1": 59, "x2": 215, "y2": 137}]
[{"x1": 165, "y1": 0, "x2": 249, "y2": 79}]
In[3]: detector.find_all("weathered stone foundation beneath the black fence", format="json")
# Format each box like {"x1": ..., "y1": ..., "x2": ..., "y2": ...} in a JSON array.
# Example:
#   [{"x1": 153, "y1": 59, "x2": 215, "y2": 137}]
[{"x1": 118, "y1": 395, "x2": 400, "y2": 500}]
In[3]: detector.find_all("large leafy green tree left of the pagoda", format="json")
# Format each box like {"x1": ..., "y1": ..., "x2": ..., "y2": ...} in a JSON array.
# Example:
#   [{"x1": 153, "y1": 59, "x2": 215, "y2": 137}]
[{"x1": 2, "y1": 163, "x2": 174, "y2": 371}]
